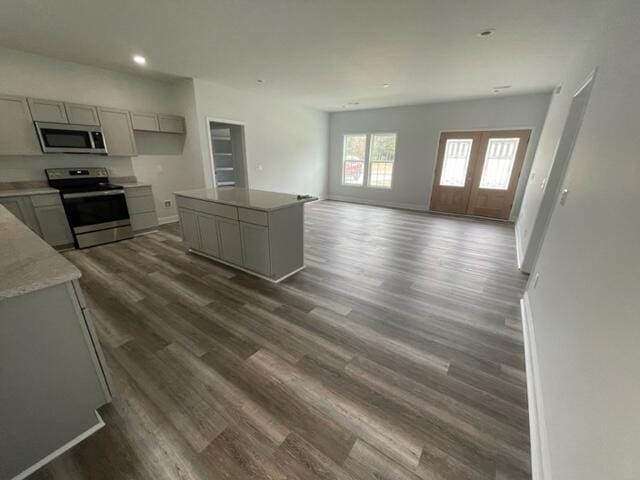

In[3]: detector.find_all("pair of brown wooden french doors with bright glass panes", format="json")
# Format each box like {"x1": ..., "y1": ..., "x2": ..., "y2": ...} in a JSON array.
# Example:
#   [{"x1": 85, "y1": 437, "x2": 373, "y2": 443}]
[{"x1": 431, "y1": 130, "x2": 531, "y2": 220}]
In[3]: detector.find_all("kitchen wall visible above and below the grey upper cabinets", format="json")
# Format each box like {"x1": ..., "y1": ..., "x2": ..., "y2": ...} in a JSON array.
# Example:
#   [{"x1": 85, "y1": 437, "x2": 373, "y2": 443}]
[{"x1": 0, "y1": 48, "x2": 196, "y2": 222}]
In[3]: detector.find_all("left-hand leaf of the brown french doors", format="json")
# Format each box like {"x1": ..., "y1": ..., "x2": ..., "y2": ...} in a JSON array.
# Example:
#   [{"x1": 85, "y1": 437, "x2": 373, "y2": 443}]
[{"x1": 431, "y1": 132, "x2": 482, "y2": 214}]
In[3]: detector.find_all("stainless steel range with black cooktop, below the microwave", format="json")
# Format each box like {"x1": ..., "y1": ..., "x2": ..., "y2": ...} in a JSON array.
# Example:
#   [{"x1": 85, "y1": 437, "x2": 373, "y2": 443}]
[{"x1": 45, "y1": 168, "x2": 133, "y2": 248}]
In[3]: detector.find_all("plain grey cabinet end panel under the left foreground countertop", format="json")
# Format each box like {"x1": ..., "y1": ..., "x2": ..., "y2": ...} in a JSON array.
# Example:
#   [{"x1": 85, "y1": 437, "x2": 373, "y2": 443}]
[{"x1": 0, "y1": 284, "x2": 105, "y2": 478}]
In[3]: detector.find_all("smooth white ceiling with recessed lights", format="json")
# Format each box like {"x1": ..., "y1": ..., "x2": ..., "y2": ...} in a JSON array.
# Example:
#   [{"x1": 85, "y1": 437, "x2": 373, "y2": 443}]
[{"x1": 0, "y1": 0, "x2": 606, "y2": 111}]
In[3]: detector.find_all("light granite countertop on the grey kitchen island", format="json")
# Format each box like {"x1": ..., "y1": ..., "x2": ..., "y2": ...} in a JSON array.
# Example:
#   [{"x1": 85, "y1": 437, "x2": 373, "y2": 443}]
[{"x1": 175, "y1": 187, "x2": 317, "y2": 211}]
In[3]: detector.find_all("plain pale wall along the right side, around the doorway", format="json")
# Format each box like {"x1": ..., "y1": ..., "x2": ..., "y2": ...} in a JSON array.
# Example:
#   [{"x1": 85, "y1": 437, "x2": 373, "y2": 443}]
[{"x1": 523, "y1": 0, "x2": 640, "y2": 480}]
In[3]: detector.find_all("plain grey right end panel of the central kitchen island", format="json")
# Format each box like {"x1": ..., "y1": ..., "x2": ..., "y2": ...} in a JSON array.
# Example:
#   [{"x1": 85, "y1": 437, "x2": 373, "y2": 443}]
[{"x1": 269, "y1": 204, "x2": 304, "y2": 279}]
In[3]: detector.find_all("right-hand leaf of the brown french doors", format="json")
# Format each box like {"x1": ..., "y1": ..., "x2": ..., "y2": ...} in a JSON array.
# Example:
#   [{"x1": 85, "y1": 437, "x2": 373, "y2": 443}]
[{"x1": 467, "y1": 130, "x2": 531, "y2": 220}]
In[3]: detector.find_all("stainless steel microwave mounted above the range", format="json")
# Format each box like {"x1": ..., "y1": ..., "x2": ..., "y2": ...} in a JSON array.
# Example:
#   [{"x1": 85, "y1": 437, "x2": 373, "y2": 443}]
[{"x1": 34, "y1": 122, "x2": 107, "y2": 155}]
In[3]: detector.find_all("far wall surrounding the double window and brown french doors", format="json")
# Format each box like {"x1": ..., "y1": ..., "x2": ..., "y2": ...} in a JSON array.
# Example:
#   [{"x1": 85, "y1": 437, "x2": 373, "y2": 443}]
[{"x1": 329, "y1": 93, "x2": 550, "y2": 218}]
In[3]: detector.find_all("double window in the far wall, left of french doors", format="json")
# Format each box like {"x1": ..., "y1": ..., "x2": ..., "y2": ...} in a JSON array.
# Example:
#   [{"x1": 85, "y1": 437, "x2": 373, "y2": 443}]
[{"x1": 342, "y1": 133, "x2": 396, "y2": 188}]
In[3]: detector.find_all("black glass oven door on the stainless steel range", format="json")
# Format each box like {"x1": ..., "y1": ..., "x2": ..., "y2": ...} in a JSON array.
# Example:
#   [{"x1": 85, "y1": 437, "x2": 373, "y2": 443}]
[{"x1": 62, "y1": 190, "x2": 131, "y2": 234}]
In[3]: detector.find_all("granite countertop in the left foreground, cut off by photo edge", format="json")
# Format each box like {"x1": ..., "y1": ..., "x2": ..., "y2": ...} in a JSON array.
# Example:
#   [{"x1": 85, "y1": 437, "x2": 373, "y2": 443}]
[{"x1": 0, "y1": 203, "x2": 80, "y2": 301}]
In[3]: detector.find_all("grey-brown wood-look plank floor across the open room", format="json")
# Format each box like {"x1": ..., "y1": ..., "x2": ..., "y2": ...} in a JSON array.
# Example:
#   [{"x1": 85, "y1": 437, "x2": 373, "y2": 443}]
[{"x1": 31, "y1": 201, "x2": 530, "y2": 480}]
